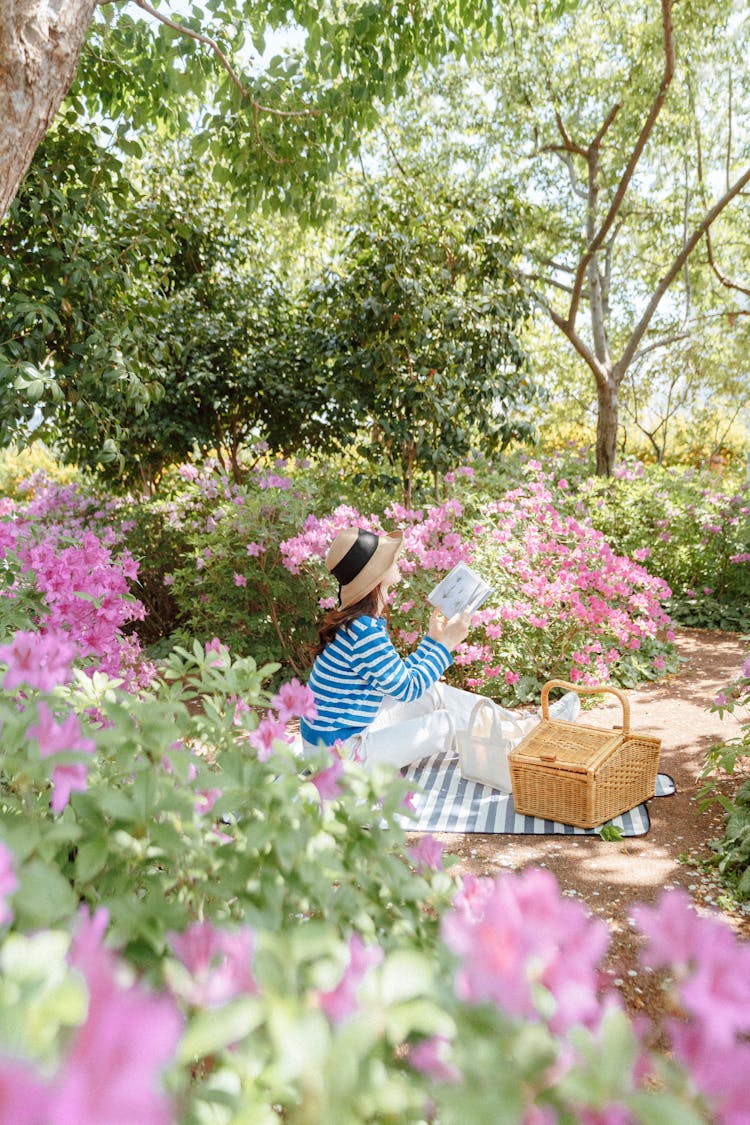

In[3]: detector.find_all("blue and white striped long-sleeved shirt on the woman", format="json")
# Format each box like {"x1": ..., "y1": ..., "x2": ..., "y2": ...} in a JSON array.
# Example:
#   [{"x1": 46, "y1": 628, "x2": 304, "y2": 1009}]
[{"x1": 301, "y1": 617, "x2": 453, "y2": 746}]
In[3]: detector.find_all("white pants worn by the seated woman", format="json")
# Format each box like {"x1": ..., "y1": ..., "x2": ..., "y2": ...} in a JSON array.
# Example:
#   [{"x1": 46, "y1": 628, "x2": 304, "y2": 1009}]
[{"x1": 303, "y1": 681, "x2": 539, "y2": 770}]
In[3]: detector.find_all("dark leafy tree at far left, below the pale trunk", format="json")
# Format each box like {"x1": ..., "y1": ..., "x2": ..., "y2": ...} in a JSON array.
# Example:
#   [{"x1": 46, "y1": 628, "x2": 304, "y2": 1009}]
[{"x1": 0, "y1": 118, "x2": 169, "y2": 452}]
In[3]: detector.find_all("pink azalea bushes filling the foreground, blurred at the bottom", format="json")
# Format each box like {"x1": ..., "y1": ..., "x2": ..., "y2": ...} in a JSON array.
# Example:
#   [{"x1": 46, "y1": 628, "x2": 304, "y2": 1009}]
[{"x1": 0, "y1": 558, "x2": 750, "y2": 1125}]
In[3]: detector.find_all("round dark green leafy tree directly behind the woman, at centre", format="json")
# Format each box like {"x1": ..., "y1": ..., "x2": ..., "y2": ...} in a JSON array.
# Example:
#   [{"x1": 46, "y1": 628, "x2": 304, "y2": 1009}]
[{"x1": 301, "y1": 191, "x2": 534, "y2": 506}]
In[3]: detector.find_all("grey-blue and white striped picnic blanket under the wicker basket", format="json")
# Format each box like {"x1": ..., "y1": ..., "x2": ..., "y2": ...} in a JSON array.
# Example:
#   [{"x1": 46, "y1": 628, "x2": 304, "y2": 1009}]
[{"x1": 403, "y1": 754, "x2": 677, "y2": 836}]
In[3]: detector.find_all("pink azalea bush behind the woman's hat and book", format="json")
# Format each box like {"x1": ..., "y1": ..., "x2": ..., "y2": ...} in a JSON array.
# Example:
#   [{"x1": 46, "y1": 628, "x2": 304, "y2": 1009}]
[{"x1": 280, "y1": 462, "x2": 676, "y2": 702}]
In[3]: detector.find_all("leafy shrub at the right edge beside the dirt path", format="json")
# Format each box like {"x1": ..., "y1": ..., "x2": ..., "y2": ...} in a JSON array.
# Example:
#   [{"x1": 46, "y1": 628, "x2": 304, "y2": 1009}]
[{"x1": 703, "y1": 655, "x2": 750, "y2": 900}]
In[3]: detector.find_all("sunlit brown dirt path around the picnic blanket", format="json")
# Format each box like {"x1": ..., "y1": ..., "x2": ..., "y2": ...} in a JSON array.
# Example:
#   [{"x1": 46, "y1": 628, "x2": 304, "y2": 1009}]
[{"x1": 416, "y1": 629, "x2": 750, "y2": 1018}]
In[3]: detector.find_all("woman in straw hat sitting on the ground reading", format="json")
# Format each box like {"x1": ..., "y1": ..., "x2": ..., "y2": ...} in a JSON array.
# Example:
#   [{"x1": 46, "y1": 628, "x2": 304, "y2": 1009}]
[{"x1": 301, "y1": 528, "x2": 579, "y2": 768}]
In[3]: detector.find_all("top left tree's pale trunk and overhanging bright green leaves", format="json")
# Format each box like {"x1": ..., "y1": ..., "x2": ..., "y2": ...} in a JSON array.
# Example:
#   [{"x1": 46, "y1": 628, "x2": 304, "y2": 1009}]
[{"x1": 0, "y1": 0, "x2": 571, "y2": 217}]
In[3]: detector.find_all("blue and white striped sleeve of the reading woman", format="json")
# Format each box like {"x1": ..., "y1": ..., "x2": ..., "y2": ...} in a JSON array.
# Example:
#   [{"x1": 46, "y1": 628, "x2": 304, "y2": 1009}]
[{"x1": 350, "y1": 618, "x2": 453, "y2": 702}]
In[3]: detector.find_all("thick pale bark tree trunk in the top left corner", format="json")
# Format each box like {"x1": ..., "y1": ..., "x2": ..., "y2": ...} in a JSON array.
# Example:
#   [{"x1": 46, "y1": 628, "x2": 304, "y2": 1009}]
[{"x1": 0, "y1": 0, "x2": 98, "y2": 219}]
